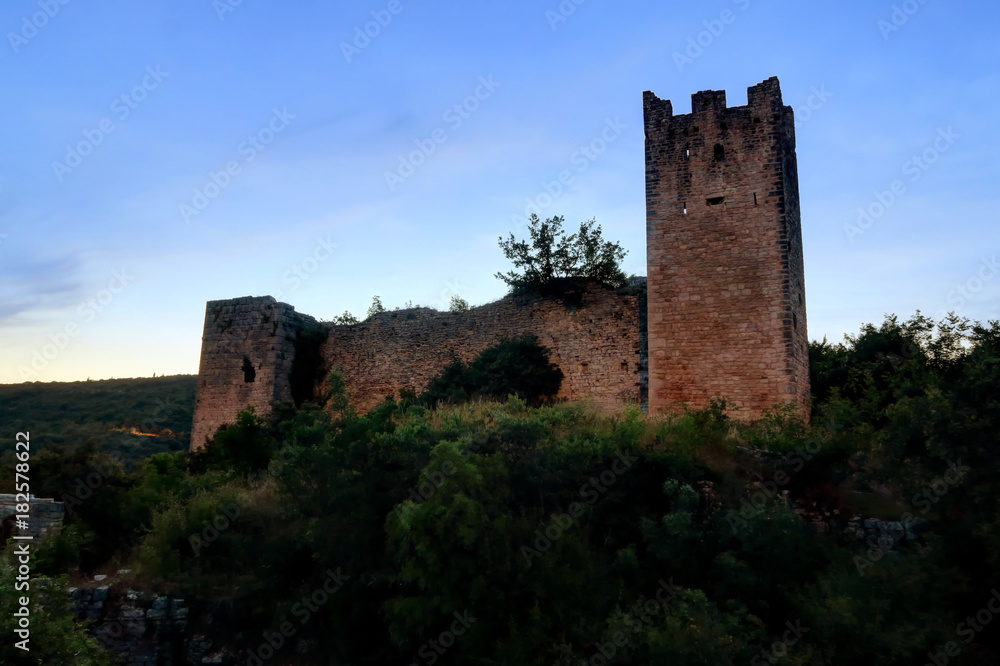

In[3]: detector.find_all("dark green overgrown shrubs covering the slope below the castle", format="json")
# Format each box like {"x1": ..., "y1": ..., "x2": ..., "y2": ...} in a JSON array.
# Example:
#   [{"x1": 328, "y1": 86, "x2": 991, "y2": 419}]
[{"x1": 0, "y1": 315, "x2": 1000, "y2": 666}]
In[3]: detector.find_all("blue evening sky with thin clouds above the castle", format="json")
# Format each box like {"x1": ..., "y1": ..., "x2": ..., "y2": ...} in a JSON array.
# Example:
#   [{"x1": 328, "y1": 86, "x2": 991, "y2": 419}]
[{"x1": 0, "y1": 0, "x2": 1000, "y2": 383}]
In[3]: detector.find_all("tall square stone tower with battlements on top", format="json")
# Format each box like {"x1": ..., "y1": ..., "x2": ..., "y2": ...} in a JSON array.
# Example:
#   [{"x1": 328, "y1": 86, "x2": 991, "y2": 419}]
[{"x1": 643, "y1": 77, "x2": 809, "y2": 419}]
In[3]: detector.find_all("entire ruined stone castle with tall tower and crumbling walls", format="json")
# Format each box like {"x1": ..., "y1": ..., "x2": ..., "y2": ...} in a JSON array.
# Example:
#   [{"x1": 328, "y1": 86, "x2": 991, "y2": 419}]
[{"x1": 191, "y1": 77, "x2": 809, "y2": 449}]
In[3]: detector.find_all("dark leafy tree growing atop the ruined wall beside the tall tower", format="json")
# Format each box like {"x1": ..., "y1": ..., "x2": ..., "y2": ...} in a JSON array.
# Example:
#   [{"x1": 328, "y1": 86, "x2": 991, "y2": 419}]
[{"x1": 496, "y1": 213, "x2": 628, "y2": 292}]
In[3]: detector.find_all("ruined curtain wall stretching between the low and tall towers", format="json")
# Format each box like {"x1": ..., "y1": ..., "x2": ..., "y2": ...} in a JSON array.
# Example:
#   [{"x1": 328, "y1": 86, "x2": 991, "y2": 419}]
[{"x1": 323, "y1": 285, "x2": 643, "y2": 411}]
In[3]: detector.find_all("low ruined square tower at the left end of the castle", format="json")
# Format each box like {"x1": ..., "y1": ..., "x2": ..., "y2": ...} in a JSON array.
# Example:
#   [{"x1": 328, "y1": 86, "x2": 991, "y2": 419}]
[{"x1": 191, "y1": 296, "x2": 319, "y2": 449}]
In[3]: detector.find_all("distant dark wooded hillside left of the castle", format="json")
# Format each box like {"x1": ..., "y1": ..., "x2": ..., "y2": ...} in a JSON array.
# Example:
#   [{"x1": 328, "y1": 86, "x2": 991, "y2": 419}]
[{"x1": 0, "y1": 375, "x2": 198, "y2": 466}]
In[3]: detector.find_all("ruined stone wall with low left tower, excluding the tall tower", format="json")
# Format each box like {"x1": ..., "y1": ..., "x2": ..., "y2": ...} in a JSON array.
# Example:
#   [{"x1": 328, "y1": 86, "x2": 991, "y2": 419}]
[{"x1": 191, "y1": 283, "x2": 645, "y2": 449}]
